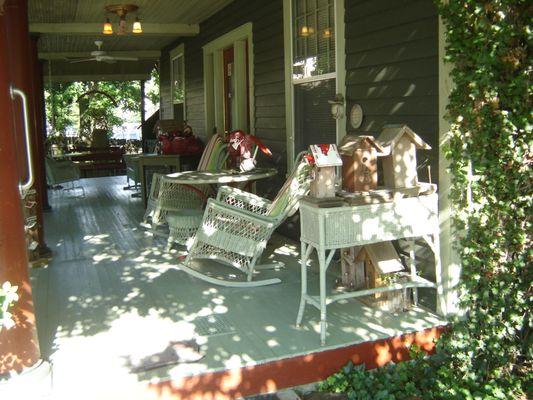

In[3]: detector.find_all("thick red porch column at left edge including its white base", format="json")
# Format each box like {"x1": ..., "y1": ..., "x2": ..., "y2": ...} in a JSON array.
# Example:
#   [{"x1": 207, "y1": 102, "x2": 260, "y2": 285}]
[{"x1": 0, "y1": 0, "x2": 50, "y2": 398}]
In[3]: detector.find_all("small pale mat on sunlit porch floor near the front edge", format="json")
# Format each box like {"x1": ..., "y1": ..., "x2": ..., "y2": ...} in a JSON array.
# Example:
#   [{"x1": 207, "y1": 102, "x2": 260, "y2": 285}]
[{"x1": 126, "y1": 340, "x2": 204, "y2": 372}]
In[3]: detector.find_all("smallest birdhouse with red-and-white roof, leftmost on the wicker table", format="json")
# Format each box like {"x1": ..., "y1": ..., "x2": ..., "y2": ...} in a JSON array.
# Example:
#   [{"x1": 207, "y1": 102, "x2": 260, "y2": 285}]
[{"x1": 309, "y1": 144, "x2": 342, "y2": 199}]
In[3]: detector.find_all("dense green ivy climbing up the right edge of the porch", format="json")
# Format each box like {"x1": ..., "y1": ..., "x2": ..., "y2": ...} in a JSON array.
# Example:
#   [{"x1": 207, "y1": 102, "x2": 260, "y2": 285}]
[{"x1": 318, "y1": 0, "x2": 533, "y2": 399}]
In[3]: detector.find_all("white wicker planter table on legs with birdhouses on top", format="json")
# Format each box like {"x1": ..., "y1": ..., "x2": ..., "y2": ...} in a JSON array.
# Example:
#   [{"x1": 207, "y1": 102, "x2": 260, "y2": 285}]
[{"x1": 296, "y1": 193, "x2": 445, "y2": 344}]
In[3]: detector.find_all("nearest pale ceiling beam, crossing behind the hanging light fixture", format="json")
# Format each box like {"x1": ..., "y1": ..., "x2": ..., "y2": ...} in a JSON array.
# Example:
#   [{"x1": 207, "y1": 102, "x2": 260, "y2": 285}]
[{"x1": 30, "y1": 22, "x2": 200, "y2": 37}]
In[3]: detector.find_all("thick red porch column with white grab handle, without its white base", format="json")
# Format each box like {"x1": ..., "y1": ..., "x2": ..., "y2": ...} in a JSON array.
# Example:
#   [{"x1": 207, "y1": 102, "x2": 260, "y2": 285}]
[{"x1": 0, "y1": 0, "x2": 40, "y2": 376}]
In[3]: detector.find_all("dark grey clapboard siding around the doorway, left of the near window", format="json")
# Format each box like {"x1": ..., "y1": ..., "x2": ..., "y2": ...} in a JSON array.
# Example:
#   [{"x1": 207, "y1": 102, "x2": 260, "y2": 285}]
[{"x1": 161, "y1": 0, "x2": 286, "y2": 186}]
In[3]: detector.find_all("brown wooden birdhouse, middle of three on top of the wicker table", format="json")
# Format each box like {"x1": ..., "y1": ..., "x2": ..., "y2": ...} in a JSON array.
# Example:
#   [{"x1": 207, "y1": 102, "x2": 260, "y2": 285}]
[{"x1": 339, "y1": 135, "x2": 383, "y2": 192}]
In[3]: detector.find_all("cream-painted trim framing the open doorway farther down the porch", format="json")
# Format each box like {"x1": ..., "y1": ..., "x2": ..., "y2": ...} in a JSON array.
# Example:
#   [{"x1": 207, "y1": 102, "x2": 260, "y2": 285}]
[{"x1": 203, "y1": 22, "x2": 255, "y2": 134}]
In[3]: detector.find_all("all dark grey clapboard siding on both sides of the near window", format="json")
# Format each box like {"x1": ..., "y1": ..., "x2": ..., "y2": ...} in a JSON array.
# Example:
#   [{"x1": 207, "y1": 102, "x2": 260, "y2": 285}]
[{"x1": 161, "y1": 0, "x2": 438, "y2": 239}]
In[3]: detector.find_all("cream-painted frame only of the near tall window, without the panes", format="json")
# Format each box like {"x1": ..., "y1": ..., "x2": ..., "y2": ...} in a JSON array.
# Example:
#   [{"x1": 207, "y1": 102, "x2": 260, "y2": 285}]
[{"x1": 283, "y1": 0, "x2": 346, "y2": 170}]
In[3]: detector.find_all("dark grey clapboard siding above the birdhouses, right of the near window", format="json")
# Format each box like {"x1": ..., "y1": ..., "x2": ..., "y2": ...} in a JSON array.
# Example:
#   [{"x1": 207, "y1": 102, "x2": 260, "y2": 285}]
[{"x1": 345, "y1": 0, "x2": 438, "y2": 182}]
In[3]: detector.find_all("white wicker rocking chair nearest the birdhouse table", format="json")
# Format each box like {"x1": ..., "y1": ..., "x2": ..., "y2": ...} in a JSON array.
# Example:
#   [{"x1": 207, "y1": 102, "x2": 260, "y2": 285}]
[{"x1": 179, "y1": 153, "x2": 311, "y2": 287}]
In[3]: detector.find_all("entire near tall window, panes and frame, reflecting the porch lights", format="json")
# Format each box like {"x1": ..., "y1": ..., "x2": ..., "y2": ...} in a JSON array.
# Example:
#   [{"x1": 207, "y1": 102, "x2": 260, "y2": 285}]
[{"x1": 284, "y1": 0, "x2": 346, "y2": 162}]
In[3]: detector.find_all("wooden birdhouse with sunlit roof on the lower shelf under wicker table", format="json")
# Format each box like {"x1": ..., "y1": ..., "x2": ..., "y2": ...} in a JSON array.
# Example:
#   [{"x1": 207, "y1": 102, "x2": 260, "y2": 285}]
[{"x1": 354, "y1": 242, "x2": 404, "y2": 298}]
